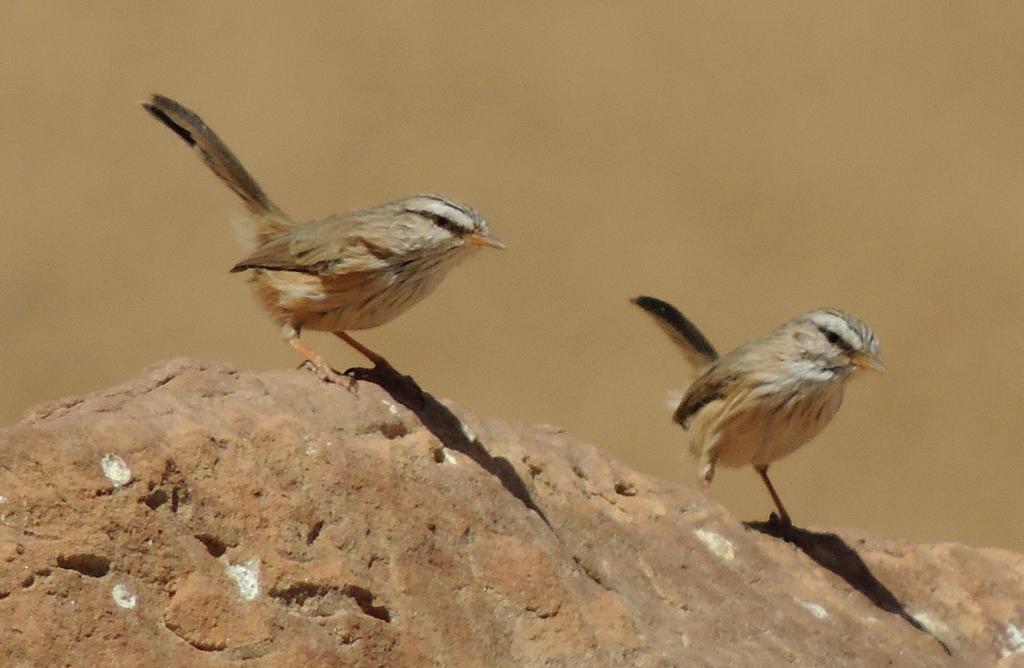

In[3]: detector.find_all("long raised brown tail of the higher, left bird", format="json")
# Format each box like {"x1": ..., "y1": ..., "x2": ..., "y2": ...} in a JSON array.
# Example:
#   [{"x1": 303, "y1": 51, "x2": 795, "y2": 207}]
[{"x1": 142, "y1": 95, "x2": 291, "y2": 241}]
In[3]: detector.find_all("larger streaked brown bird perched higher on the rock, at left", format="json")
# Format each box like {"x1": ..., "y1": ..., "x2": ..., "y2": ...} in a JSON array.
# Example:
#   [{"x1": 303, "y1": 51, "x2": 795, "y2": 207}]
[{"x1": 141, "y1": 94, "x2": 505, "y2": 381}]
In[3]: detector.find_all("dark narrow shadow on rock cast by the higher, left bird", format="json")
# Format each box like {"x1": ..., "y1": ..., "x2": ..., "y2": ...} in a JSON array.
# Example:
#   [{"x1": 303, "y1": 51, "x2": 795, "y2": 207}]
[{"x1": 345, "y1": 363, "x2": 554, "y2": 531}]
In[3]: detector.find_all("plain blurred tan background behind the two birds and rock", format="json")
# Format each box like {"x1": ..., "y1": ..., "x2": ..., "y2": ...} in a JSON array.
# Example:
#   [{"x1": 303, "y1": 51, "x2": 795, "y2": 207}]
[{"x1": 0, "y1": 2, "x2": 1024, "y2": 550}]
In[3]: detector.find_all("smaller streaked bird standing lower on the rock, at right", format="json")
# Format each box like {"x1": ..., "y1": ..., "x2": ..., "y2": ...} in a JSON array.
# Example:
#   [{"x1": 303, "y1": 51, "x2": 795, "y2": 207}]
[{"x1": 632, "y1": 296, "x2": 885, "y2": 529}]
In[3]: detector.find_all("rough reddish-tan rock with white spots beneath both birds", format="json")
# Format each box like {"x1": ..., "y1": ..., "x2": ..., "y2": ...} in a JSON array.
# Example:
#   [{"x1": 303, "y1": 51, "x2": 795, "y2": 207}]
[{"x1": 0, "y1": 360, "x2": 1024, "y2": 667}]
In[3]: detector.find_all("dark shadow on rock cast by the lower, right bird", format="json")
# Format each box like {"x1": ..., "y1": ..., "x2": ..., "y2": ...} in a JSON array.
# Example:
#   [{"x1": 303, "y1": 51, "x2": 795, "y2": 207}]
[{"x1": 744, "y1": 513, "x2": 952, "y2": 656}]
